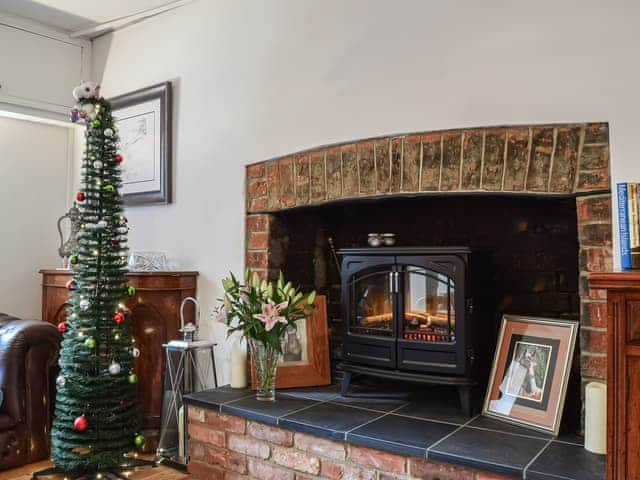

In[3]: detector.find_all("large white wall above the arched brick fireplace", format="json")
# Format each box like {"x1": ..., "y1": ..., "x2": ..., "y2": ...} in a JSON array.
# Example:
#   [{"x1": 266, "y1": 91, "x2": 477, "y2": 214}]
[{"x1": 93, "y1": 0, "x2": 640, "y2": 378}]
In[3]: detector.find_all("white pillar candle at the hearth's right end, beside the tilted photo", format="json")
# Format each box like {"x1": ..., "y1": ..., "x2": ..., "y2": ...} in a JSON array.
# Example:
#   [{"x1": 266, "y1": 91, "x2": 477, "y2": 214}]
[{"x1": 584, "y1": 382, "x2": 607, "y2": 454}]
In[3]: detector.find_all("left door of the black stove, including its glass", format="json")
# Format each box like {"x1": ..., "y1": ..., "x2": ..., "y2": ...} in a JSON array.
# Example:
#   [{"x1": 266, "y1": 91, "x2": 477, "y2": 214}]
[{"x1": 342, "y1": 257, "x2": 397, "y2": 368}]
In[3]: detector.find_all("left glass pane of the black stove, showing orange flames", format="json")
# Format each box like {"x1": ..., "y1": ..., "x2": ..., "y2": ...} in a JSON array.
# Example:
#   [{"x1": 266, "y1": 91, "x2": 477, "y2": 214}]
[{"x1": 349, "y1": 266, "x2": 394, "y2": 337}]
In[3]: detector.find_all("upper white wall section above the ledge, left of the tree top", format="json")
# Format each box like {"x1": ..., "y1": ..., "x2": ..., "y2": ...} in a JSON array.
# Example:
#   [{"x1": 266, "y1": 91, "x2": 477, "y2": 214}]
[{"x1": 0, "y1": 14, "x2": 91, "y2": 120}]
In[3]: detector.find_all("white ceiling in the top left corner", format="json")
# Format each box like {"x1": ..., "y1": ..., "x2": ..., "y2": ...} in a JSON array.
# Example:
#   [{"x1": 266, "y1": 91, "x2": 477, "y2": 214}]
[{"x1": 0, "y1": 0, "x2": 174, "y2": 32}]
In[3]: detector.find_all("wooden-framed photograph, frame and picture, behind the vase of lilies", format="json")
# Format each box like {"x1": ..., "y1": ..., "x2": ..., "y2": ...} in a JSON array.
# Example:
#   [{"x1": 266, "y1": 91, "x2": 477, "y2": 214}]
[{"x1": 251, "y1": 295, "x2": 331, "y2": 388}]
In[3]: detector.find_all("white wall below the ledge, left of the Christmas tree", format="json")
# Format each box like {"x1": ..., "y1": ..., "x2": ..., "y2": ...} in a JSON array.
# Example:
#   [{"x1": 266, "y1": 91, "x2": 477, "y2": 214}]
[{"x1": 0, "y1": 116, "x2": 74, "y2": 318}]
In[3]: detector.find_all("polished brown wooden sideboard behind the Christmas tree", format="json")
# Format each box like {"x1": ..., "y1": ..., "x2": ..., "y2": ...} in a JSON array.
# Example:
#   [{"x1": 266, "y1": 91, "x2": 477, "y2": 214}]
[{"x1": 40, "y1": 270, "x2": 198, "y2": 438}]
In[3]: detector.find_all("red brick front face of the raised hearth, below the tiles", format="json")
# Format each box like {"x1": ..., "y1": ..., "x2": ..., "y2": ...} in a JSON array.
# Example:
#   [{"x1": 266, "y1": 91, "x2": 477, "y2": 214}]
[{"x1": 189, "y1": 406, "x2": 507, "y2": 480}]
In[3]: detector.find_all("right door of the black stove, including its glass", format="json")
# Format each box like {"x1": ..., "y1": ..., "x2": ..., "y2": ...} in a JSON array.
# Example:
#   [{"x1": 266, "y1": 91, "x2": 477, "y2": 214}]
[{"x1": 397, "y1": 256, "x2": 466, "y2": 374}]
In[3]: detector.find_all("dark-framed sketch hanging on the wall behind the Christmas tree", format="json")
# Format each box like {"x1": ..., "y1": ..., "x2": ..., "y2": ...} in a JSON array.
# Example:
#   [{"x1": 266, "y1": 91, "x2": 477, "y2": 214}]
[{"x1": 110, "y1": 82, "x2": 171, "y2": 205}]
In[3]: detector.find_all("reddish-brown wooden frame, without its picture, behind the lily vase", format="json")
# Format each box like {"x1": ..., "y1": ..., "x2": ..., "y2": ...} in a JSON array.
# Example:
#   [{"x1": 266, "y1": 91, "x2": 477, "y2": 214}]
[{"x1": 251, "y1": 295, "x2": 331, "y2": 390}]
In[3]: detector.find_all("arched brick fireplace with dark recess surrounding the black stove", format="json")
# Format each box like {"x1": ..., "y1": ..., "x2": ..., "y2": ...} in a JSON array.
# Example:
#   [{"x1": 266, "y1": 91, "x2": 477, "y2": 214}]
[{"x1": 246, "y1": 123, "x2": 613, "y2": 432}]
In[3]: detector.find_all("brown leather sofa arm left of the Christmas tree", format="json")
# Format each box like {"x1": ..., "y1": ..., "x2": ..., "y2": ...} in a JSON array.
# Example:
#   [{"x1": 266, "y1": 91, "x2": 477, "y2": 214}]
[{"x1": 0, "y1": 313, "x2": 60, "y2": 470}]
